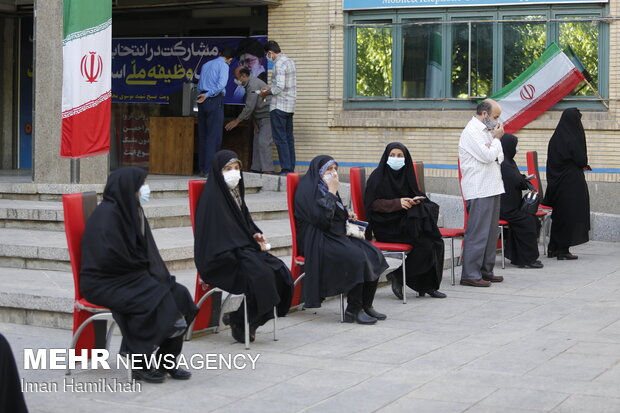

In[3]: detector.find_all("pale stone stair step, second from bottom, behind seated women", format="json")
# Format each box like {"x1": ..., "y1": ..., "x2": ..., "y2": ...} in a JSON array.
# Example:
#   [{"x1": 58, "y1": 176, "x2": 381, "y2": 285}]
[{"x1": 0, "y1": 219, "x2": 291, "y2": 271}]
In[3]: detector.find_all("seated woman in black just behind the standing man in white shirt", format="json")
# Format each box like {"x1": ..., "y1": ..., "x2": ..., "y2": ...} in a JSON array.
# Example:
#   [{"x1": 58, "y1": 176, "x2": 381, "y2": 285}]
[{"x1": 499, "y1": 133, "x2": 543, "y2": 268}]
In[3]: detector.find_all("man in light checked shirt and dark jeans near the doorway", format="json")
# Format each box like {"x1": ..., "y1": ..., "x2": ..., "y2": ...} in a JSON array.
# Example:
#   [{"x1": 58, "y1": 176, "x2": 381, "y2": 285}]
[{"x1": 260, "y1": 40, "x2": 297, "y2": 175}]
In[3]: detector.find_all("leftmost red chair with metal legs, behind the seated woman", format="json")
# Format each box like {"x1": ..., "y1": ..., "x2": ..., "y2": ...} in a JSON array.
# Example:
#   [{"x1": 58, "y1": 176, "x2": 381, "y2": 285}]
[{"x1": 62, "y1": 192, "x2": 117, "y2": 378}]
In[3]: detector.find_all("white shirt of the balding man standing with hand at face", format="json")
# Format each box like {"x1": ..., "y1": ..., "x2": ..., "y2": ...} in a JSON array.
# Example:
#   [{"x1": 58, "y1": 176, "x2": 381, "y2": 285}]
[{"x1": 459, "y1": 116, "x2": 504, "y2": 201}]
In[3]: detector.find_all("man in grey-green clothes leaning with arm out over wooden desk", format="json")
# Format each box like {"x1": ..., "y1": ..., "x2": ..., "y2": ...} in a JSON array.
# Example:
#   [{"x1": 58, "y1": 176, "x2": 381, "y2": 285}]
[{"x1": 225, "y1": 66, "x2": 273, "y2": 174}]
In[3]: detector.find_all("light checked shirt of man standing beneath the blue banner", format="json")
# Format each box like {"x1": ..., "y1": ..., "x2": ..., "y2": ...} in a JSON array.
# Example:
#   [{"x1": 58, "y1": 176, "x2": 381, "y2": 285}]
[{"x1": 269, "y1": 53, "x2": 297, "y2": 113}]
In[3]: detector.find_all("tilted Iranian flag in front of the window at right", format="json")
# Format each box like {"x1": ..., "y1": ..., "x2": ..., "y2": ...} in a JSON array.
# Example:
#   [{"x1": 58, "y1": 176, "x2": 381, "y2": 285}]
[{"x1": 489, "y1": 43, "x2": 584, "y2": 133}]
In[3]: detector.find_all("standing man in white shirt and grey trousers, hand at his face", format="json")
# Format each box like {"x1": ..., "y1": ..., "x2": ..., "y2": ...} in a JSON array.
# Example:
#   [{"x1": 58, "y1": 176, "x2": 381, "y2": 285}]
[{"x1": 459, "y1": 99, "x2": 504, "y2": 287}]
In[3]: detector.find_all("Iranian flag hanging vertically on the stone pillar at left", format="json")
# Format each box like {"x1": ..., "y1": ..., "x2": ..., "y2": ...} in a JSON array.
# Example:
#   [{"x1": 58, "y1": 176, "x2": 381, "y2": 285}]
[{"x1": 60, "y1": 0, "x2": 112, "y2": 158}]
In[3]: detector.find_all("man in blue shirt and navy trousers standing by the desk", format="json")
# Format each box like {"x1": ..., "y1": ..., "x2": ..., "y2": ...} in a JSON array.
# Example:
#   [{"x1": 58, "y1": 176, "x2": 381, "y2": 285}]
[{"x1": 196, "y1": 46, "x2": 235, "y2": 177}]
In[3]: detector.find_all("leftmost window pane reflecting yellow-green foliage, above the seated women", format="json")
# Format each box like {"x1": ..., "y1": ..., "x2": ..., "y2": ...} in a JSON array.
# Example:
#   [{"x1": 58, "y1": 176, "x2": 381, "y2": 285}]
[{"x1": 355, "y1": 27, "x2": 392, "y2": 96}]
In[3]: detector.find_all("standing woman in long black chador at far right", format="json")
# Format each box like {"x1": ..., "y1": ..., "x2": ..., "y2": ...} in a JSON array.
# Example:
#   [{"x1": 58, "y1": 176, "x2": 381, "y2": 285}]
[{"x1": 544, "y1": 108, "x2": 591, "y2": 260}]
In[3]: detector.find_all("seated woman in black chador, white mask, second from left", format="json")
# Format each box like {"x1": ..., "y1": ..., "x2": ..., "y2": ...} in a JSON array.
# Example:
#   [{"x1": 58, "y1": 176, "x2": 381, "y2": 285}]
[{"x1": 194, "y1": 150, "x2": 293, "y2": 343}]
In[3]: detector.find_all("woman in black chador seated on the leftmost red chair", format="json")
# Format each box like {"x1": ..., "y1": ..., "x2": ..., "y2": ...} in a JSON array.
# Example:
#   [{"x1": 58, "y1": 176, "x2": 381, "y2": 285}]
[{"x1": 80, "y1": 167, "x2": 197, "y2": 383}]
